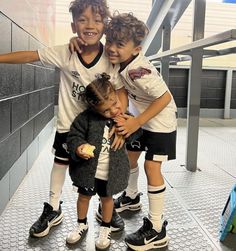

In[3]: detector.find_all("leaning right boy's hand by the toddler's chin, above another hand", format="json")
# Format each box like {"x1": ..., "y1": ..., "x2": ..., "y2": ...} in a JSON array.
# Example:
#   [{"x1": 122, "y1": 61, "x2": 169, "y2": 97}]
[{"x1": 114, "y1": 114, "x2": 141, "y2": 138}]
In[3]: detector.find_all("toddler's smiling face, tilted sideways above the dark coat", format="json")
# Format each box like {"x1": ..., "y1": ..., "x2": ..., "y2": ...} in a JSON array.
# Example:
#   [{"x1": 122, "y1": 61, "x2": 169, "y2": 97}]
[{"x1": 95, "y1": 92, "x2": 122, "y2": 119}]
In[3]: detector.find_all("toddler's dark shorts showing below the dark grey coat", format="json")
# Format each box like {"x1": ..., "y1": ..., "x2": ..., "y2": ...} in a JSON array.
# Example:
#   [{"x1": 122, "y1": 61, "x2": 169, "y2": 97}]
[{"x1": 74, "y1": 178, "x2": 108, "y2": 197}]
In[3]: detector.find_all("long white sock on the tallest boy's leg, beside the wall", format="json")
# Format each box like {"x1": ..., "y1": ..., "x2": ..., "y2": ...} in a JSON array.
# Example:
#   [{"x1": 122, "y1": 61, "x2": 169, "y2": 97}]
[{"x1": 49, "y1": 163, "x2": 68, "y2": 210}]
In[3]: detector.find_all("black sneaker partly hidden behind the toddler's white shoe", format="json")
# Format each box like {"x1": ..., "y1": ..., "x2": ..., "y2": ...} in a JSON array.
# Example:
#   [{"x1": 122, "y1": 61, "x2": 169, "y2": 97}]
[{"x1": 96, "y1": 203, "x2": 125, "y2": 232}]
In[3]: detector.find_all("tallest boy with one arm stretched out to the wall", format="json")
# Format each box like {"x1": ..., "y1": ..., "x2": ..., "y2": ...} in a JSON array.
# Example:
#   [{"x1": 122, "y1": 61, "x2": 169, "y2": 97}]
[{"x1": 0, "y1": 0, "x2": 124, "y2": 237}]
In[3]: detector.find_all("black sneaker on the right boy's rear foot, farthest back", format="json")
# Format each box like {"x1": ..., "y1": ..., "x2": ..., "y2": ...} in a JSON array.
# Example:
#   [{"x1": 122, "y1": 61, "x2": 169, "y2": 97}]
[{"x1": 114, "y1": 191, "x2": 142, "y2": 213}]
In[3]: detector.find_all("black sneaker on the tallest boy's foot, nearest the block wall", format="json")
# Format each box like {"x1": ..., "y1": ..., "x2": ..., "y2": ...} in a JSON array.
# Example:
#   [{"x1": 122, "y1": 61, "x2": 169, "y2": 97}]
[{"x1": 29, "y1": 201, "x2": 63, "y2": 237}]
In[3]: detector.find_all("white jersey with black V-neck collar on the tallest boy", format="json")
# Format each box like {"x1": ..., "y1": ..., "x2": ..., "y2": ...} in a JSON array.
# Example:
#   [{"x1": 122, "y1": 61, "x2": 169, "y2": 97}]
[{"x1": 38, "y1": 44, "x2": 123, "y2": 133}]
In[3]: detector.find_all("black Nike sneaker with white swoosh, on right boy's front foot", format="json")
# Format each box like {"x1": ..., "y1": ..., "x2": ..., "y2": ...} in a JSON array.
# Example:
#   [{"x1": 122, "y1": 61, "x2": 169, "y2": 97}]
[{"x1": 125, "y1": 217, "x2": 169, "y2": 251}]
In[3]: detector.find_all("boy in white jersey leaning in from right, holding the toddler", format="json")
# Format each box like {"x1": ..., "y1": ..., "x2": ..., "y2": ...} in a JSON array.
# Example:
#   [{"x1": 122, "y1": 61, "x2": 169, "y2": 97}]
[{"x1": 105, "y1": 13, "x2": 177, "y2": 251}]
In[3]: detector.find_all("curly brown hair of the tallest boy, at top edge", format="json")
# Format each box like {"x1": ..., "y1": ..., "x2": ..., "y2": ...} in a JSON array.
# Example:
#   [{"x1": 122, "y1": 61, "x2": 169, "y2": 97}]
[{"x1": 69, "y1": 0, "x2": 111, "y2": 20}]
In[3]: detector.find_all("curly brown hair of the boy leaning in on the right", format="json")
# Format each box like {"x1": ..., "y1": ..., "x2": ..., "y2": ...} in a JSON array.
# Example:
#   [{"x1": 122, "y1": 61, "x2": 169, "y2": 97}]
[{"x1": 105, "y1": 13, "x2": 148, "y2": 46}]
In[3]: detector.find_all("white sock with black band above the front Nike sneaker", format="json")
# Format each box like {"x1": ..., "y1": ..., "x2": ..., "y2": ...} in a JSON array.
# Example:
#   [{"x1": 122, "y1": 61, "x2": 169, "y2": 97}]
[{"x1": 148, "y1": 184, "x2": 166, "y2": 232}]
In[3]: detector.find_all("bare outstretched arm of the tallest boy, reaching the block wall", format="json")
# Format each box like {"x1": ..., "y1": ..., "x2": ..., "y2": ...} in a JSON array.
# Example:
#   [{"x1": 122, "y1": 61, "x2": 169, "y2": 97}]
[{"x1": 0, "y1": 51, "x2": 39, "y2": 64}]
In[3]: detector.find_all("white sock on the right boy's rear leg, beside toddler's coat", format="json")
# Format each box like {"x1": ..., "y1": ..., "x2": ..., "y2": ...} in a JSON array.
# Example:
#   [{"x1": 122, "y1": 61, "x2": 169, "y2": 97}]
[{"x1": 125, "y1": 166, "x2": 139, "y2": 199}]
